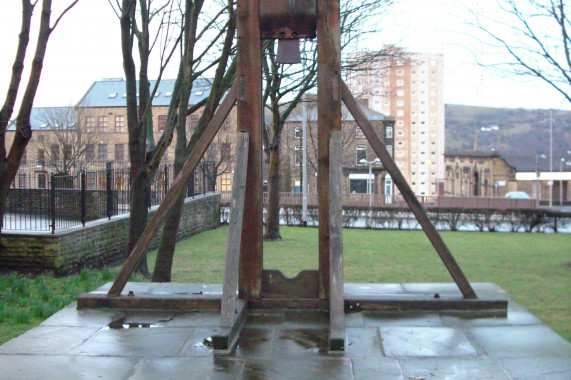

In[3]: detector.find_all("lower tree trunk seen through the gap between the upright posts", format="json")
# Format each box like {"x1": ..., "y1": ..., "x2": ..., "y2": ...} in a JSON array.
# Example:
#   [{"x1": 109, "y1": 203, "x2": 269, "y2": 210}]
[{"x1": 264, "y1": 144, "x2": 282, "y2": 240}]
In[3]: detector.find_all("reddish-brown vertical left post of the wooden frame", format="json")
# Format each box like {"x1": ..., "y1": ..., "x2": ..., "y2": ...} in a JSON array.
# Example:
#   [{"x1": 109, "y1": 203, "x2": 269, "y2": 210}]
[{"x1": 236, "y1": 0, "x2": 263, "y2": 298}]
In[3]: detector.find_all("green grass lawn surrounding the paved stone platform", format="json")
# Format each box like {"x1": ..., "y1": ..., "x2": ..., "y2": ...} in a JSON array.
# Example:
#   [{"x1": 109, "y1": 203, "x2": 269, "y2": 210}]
[{"x1": 0, "y1": 227, "x2": 571, "y2": 344}]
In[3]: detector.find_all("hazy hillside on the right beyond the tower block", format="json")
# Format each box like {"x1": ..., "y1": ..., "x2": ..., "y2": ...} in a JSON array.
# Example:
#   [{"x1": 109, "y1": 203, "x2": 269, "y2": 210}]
[{"x1": 445, "y1": 104, "x2": 571, "y2": 160}]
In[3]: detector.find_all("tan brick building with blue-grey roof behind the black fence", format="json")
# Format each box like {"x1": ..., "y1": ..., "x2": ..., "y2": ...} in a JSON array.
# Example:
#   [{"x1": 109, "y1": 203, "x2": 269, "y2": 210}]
[{"x1": 6, "y1": 78, "x2": 236, "y2": 190}]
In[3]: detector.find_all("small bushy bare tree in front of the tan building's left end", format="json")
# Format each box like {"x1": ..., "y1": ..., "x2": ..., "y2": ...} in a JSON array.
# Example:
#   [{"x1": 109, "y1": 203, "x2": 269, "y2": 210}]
[{"x1": 37, "y1": 106, "x2": 105, "y2": 174}]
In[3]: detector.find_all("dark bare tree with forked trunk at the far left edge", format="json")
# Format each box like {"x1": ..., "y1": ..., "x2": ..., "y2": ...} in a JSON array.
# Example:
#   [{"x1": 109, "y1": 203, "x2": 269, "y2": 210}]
[{"x1": 0, "y1": 0, "x2": 79, "y2": 232}]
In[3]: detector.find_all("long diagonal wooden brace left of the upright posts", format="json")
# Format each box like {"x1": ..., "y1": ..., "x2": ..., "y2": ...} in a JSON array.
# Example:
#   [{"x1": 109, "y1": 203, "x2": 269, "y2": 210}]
[{"x1": 108, "y1": 83, "x2": 237, "y2": 296}]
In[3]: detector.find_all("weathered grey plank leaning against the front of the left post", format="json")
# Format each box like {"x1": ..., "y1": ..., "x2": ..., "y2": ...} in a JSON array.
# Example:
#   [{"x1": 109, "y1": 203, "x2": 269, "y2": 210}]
[{"x1": 220, "y1": 132, "x2": 248, "y2": 327}]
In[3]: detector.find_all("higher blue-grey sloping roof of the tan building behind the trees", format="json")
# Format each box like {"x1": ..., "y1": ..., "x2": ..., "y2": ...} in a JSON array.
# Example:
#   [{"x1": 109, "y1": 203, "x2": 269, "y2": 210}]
[{"x1": 78, "y1": 78, "x2": 211, "y2": 107}]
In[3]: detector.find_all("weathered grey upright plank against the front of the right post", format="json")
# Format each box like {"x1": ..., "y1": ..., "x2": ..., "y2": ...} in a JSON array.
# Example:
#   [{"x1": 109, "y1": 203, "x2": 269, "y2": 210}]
[{"x1": 329, "y1": 130, "x2": 345, "y2": 351}]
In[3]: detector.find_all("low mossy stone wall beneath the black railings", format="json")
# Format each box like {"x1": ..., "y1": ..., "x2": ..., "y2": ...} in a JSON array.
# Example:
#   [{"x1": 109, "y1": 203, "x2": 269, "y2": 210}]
[{"x1": 0, "y1": 193, "x2": 220, "y2": 275}]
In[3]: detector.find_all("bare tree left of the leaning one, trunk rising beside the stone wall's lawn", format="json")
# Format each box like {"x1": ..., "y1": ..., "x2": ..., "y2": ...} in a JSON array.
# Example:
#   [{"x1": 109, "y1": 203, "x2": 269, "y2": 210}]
[{"x1": 109, "y1": 0, "x2": 180, "y2": 275}]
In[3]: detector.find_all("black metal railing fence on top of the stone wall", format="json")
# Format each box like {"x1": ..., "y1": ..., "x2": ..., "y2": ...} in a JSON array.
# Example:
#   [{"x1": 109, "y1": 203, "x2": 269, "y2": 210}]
[{"x1": 2, "y1": 161, "x2": 216, "y2": 233}]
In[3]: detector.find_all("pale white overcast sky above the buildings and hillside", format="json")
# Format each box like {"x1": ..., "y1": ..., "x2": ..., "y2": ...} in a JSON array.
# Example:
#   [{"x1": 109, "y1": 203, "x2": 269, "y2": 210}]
[{"x1": 0, "y1": 0, "x2": 571, "y2": 109}]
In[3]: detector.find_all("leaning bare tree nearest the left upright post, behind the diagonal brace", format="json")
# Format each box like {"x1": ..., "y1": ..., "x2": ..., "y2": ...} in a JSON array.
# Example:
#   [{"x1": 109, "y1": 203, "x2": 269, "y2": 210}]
[{"x1": 153, "y1": 0, "x2": 236, "y2": 282}]
